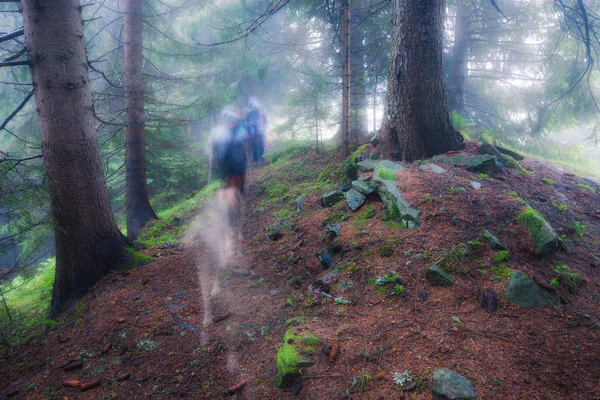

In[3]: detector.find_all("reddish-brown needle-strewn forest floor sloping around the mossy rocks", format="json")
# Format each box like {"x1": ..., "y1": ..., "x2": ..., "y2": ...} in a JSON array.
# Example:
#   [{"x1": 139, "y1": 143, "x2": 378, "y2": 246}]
[{"x1": 0, "y1": 143, "x2": 600, "y2": 399}]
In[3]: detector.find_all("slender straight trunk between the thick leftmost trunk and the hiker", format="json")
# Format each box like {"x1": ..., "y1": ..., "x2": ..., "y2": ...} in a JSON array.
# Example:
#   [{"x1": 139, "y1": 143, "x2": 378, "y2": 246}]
[{"x1": 124, "y1": 0, "x2": 157, "y2": 239}]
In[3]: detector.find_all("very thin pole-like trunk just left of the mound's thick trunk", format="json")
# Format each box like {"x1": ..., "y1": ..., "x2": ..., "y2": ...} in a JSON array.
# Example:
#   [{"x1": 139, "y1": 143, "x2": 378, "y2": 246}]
[{"x1": 342, "y1": 0, "x2": 350, "y2": 159}]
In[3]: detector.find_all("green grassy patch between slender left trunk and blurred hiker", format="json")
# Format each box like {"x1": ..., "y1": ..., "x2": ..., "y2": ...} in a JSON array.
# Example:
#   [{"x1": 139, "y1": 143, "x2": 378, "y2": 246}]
[{"x1": 137, "y1": 181, "x2": 221, "y2": 247}]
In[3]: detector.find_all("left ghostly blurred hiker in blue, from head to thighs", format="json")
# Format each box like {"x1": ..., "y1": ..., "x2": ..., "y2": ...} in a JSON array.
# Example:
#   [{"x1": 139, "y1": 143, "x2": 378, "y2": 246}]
[{"x1": 209, "y1": 106, "x2": 247, "y2": 226}]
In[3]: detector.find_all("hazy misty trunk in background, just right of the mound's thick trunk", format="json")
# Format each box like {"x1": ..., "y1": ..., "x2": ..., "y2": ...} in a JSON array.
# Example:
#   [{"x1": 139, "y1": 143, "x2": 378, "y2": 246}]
[{"x1": 448, "y1": 1, "x2": 469, "y2": 114}]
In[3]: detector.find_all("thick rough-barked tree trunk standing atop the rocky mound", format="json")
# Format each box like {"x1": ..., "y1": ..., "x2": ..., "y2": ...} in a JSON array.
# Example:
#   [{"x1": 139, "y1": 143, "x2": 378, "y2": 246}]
[{"x1": 382, "y1": 0, "x2": 464, "y2": 161}]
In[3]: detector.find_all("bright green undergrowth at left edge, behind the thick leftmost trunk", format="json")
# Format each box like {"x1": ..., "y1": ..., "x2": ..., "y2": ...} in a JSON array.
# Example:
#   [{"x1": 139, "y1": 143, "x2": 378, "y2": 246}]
[{"x1": 0, "y1": 258, "x2": 56, "y2": 347}]
